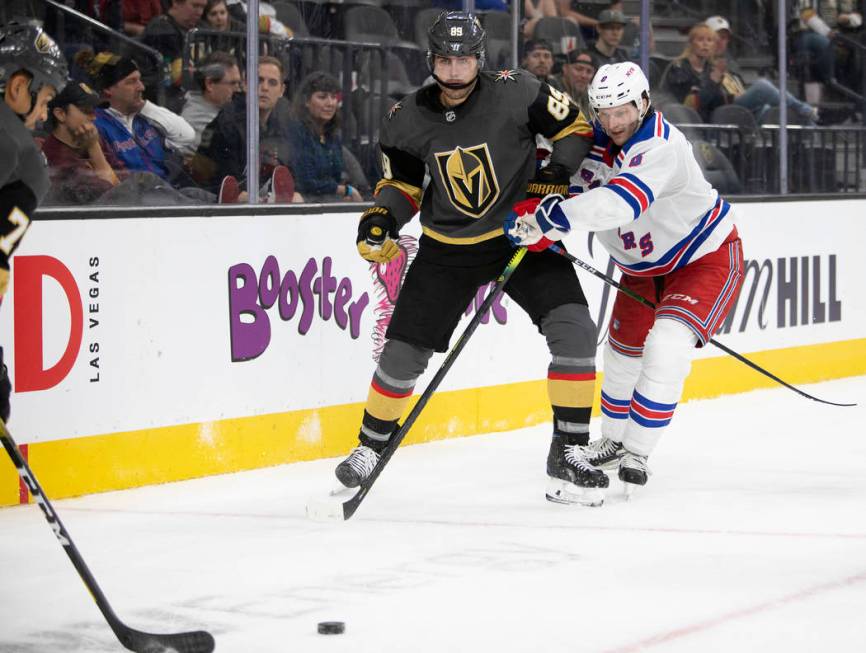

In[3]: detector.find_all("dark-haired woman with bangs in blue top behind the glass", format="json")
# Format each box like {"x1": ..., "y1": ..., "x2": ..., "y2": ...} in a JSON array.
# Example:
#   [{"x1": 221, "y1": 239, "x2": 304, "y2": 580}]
[{"x1": 289, "y1": 71, "x2": 366, "y2": 202}]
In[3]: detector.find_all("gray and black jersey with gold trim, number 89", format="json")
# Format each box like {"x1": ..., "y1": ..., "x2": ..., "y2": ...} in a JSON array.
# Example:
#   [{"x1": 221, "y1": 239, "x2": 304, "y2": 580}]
[{"x1": 376, "y1": 70, "x2": 592, "y2": 245}]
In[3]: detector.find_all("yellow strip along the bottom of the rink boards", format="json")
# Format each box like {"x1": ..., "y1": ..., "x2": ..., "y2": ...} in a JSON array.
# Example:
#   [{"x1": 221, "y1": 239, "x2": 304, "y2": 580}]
[{"x1": 0, "y1": 338, "x2": 866, "y2": 506}]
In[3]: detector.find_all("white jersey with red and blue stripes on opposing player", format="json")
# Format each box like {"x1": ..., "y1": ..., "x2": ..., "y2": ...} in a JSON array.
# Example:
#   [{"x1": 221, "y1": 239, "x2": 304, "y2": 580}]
[{"x1": 560, "y1": 112, "x2": 734, "y2": 276}]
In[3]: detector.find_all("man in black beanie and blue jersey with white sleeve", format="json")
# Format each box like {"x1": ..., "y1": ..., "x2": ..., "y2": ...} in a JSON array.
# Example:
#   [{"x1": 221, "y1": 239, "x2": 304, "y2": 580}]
[{"x1": 76, "y1": 51, "x2": 206, "y2": 196}]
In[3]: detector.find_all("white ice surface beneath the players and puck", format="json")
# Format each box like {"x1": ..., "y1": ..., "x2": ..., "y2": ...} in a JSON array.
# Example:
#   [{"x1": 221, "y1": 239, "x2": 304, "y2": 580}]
[{"x1": 0, "y1": 372, "x2": 866, "y2": 653}]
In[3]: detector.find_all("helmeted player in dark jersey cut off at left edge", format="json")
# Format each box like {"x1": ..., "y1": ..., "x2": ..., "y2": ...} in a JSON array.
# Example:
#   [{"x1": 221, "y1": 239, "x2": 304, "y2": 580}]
[{"x1": 0, "y1": 23, "x2": 67, "y2": 422}]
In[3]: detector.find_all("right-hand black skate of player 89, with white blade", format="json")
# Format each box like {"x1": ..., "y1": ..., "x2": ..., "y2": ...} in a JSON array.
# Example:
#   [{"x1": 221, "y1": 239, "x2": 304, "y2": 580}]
[{"x1": 546, "y1": 438, "x2": 610, "y2": 506}]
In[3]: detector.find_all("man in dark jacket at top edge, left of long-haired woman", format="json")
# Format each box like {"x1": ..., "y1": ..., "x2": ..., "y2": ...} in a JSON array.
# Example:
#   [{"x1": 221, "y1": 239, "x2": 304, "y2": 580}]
[{"x1": 141, "y1": 0, "x2": 206, "y2": 111}]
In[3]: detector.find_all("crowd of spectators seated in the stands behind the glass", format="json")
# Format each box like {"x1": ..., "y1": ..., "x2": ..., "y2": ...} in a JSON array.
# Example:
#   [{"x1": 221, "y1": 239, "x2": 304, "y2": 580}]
[{"x1": 1, "y1": 0, "x2": 862, "y2": 205}]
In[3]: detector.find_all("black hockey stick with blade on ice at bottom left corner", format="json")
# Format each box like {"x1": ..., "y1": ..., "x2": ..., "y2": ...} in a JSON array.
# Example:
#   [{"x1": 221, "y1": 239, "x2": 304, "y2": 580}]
[{"x1": 0, "y1": 420, "x2": 215, "y2": 653}]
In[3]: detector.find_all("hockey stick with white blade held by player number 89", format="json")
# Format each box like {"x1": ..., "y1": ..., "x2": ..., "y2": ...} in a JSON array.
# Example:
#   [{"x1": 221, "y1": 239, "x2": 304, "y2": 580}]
[{"x1": 307, "y1": 247, "x2": 526, "y2": 520}]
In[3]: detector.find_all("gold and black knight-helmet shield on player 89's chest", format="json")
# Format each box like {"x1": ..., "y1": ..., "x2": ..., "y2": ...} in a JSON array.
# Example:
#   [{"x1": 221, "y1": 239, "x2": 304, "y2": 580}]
[{"x1": 436, "y1": 143, "x2": 499, "y2": 218}]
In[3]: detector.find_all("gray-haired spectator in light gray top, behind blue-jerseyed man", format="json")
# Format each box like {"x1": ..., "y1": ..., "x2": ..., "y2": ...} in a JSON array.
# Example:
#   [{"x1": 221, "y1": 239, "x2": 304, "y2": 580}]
[{"x1": 180, "y1": 51, "x2": 241, "y2": 156}]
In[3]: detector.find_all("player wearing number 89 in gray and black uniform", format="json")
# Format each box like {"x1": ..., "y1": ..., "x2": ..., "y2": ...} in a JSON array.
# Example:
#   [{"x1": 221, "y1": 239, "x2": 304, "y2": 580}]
[{"x1": 336, "y1": 11, "x2": 608, "y2": 505}]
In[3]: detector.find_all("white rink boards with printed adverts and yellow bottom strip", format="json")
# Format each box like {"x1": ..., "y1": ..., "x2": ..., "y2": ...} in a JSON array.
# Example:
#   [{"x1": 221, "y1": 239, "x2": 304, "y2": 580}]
[{"x1": 0, "y1": 199, "x2": 866, "y2": 505}]
